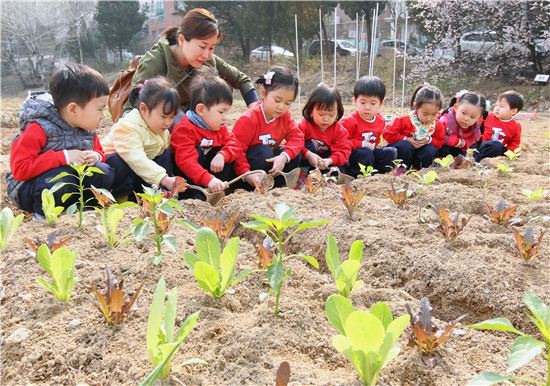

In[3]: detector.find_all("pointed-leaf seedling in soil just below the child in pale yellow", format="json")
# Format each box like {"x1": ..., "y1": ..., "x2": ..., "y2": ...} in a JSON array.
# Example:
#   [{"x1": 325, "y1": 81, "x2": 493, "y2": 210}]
[{"x1": 134, "y1": 186, "x2": 183, "y2": 265}]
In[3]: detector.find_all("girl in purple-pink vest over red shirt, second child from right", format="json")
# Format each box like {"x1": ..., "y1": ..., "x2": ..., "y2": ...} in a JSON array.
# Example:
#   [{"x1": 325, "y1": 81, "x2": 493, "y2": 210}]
[{"x1": 437, "y1": 90, "x2": 487, "y2": 158}]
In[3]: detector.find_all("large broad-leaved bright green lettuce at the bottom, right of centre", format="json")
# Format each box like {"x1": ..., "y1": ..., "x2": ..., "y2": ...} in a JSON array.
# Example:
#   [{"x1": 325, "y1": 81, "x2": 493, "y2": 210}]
[{"x1": 325, "y1": 294, "x2": 410, "y2": 386}]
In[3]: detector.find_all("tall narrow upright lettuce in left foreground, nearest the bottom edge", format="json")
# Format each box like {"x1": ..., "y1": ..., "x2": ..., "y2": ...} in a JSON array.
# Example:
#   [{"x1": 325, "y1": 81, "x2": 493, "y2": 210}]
[{"x1": 148, "y1": 277, "x2": 200, "y2": 384}]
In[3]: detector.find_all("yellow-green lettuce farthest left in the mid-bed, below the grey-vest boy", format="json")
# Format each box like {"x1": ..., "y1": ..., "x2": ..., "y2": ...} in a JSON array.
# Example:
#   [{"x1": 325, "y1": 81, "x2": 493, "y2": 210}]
[{"x1": 36, "y1": 244, "x2": 77, "y2": 303}]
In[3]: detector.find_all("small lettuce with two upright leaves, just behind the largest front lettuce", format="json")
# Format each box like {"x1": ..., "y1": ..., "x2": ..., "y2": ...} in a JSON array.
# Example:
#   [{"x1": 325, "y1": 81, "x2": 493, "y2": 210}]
[{"x1": 325, "y1": 235, "x2": 364, "y2": 298}]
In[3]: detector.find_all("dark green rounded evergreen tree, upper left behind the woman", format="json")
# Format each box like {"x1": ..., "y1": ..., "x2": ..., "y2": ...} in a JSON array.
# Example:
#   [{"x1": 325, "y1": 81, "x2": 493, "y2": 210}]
[{"x1": 95, "y1": 1, "x2": 146, "y2": 62}]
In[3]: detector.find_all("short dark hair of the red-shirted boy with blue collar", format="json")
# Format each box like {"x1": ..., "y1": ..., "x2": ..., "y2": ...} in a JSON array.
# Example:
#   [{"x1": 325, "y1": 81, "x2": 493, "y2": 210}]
[{"x1": 189, "y1": 69, "x2": 233, "y2": 111}]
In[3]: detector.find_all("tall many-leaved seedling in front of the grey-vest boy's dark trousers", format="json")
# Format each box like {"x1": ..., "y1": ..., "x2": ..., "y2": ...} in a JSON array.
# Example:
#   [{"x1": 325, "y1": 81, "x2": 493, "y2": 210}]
[{"x1": 50, "y1": 164, "x2": 105, "y2": 228}]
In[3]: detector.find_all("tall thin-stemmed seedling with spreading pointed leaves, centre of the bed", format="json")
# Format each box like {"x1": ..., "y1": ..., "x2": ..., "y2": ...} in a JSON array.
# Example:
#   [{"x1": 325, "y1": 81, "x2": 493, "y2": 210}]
[{"x1": 241, "y1": 203, "x2": 328, "y2": 316}]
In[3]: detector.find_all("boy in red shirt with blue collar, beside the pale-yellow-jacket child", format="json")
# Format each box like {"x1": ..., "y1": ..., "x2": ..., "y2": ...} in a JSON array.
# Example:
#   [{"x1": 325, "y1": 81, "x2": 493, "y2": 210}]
[{"x1": 171, "y1": 74, "x2": 241, "y2": 198}]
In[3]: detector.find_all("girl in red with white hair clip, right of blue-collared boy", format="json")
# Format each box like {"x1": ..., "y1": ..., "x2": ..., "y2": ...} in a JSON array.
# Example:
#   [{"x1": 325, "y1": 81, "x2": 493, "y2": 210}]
[{"x1": 233, "y1": 67, "x2": 304, "y2": 187}]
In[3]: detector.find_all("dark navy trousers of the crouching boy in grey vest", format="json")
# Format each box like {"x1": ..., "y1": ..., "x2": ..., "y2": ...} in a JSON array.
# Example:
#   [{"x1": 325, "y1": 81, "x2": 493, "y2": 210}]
[{"x1": 18, "y1": 162, "x2": 115, "y2": 216}]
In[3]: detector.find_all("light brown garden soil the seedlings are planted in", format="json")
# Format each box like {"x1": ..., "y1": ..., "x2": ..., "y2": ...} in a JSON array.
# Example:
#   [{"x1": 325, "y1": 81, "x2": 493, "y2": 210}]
[{"x1": 0, "y1": 101, "x2": 550, "y2": 386}]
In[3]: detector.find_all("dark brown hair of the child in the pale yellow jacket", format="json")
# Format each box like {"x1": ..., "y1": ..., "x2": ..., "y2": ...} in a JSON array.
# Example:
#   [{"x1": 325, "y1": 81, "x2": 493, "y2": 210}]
[{"x1": 129, "y1": 76, "x2": 180, "y2": 115}]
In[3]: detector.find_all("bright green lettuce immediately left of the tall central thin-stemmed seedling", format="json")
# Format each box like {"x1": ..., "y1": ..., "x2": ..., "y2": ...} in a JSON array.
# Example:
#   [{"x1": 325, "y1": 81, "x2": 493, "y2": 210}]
[{"x1": 183, "y1": 227, "x2": 254, "y2": 299}]
